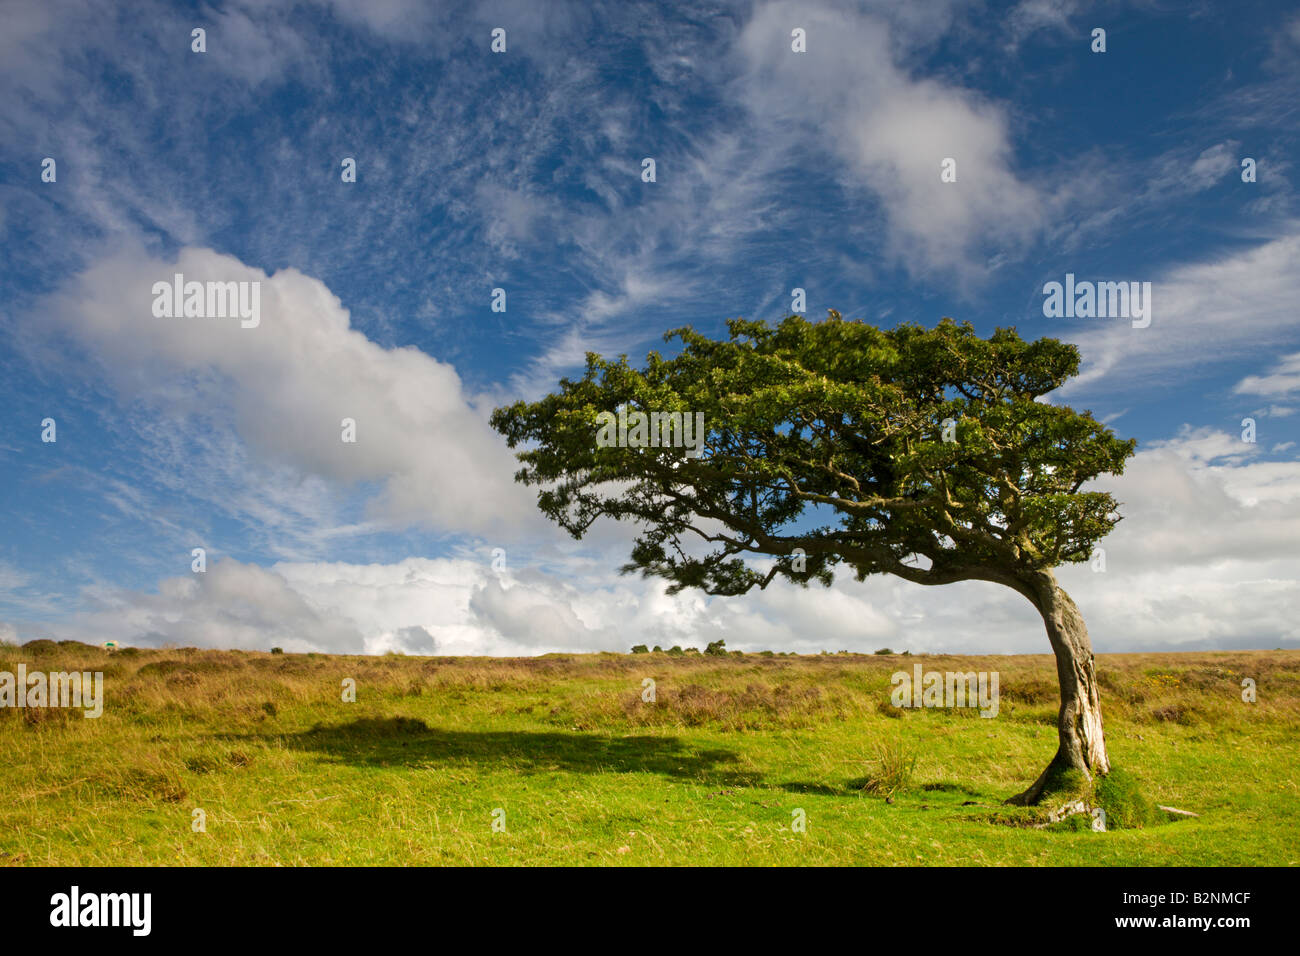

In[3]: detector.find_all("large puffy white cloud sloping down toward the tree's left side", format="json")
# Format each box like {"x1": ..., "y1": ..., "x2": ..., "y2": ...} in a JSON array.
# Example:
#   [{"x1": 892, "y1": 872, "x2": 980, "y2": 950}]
[{"x1": 51, "y1": 248, "x2": 534, "y2": 533}]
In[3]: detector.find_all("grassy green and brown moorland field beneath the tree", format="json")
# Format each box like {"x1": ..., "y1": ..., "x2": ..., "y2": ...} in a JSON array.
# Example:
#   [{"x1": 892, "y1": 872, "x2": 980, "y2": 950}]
[{"x1": 0, "y1": 641, "x2": 1300, "y2": 866}]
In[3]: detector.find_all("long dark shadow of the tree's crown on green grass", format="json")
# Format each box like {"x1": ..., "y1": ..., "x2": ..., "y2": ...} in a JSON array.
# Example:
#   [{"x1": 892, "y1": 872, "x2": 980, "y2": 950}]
[{"x1": 227, "y1": 717, "x2": 757, "y2": 787}]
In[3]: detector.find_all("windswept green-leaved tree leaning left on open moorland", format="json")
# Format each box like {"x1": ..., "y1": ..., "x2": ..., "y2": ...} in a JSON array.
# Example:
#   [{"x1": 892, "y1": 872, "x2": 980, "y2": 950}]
[{"x1": 491, "y1": 310, "x2": 1136, "y2": 803}]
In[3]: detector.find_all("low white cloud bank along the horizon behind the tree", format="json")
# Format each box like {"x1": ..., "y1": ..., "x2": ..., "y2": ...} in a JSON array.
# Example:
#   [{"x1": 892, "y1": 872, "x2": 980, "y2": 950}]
[{"x1": 32, "y1": 428, "x2": 1300, "y2": 656}]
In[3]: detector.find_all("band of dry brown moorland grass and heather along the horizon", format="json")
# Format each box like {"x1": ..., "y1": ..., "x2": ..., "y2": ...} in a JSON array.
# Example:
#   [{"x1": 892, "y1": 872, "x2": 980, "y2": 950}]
[{"x1": 0, "y1": 641, "x2": 1300, "y2": 731}]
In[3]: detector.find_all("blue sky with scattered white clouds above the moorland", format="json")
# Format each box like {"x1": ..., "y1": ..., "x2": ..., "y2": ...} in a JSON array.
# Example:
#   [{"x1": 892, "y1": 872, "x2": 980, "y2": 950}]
[{"x1": 0, "y1": 0, "x2": 1300, "y2": 654}]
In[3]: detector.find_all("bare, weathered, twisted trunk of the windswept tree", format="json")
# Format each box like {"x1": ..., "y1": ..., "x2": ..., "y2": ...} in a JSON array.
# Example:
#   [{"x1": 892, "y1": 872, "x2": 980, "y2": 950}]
[{"x1": 1008, "y1": 571, "x2": 1110, "y2": 804}]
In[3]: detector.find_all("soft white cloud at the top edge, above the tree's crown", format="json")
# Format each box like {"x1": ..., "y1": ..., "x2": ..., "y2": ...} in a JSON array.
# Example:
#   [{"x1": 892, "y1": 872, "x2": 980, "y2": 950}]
[{"x1": 735, "y1": 1, "x2": 1045, "y2": 282}]
